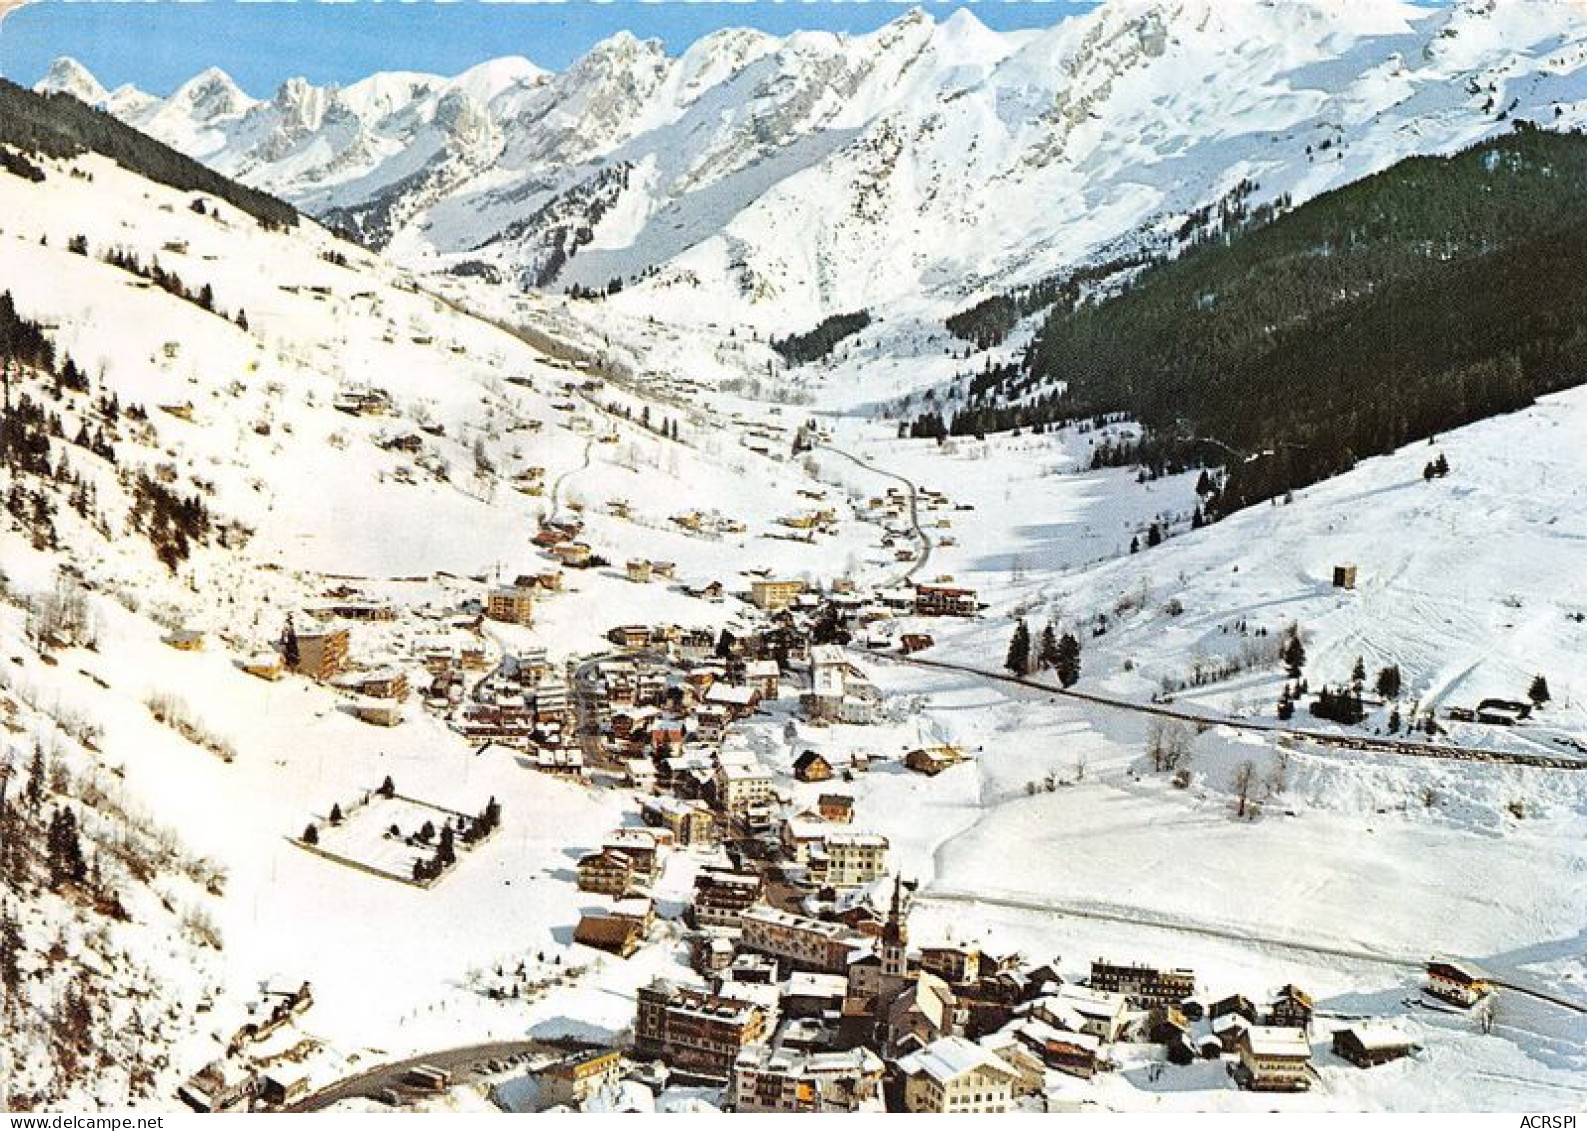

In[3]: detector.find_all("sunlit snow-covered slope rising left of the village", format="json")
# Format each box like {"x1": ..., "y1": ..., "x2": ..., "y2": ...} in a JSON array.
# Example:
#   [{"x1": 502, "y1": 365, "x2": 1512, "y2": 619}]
[{"x1": 0, "y1": 132, "x2": 890, "y2": 1109}]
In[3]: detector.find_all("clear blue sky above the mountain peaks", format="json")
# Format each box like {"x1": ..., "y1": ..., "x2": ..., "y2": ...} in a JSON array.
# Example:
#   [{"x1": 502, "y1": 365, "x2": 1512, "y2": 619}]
[{"x1": 0, "y1": 0, "x2": 1090, "y2": 97}]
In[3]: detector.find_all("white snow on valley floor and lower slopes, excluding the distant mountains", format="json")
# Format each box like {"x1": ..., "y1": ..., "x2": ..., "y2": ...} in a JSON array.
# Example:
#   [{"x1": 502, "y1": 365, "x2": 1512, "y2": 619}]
[{"x1": 0, "y1": 126, "x2": 1587, "y2": 1110}]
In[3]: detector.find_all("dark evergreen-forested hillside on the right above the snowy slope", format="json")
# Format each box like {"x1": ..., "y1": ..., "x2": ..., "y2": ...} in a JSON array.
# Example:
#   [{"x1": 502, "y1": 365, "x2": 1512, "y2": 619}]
[{"x1": 943, "y1": 124, "x2": 1587, "y2": 519}]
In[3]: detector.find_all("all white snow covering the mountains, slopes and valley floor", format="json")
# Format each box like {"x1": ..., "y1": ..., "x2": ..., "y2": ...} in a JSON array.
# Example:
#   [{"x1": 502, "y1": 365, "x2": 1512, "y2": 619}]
[{"x1": 9, "y1": 0, "x2": 1587, "y2": 1110}]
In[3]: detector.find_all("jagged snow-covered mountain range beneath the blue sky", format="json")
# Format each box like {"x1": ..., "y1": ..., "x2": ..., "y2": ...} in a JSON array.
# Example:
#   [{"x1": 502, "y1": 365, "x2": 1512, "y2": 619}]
[{"x1": 40, "y1": 0, "x2": 1587, "y2": 325}]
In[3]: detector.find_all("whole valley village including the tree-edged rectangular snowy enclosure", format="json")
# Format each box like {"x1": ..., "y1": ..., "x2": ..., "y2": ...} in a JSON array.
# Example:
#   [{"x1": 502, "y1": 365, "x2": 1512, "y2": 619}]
[{"x1": 167, "y1": 466, "x2": 1548, "y2": 1114}]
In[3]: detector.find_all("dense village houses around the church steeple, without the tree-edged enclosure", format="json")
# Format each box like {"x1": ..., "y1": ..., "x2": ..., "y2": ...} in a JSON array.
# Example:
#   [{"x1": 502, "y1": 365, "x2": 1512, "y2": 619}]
[{"x1": 207, "y1": 530, "x2": 1472, "y2": 1114}]
